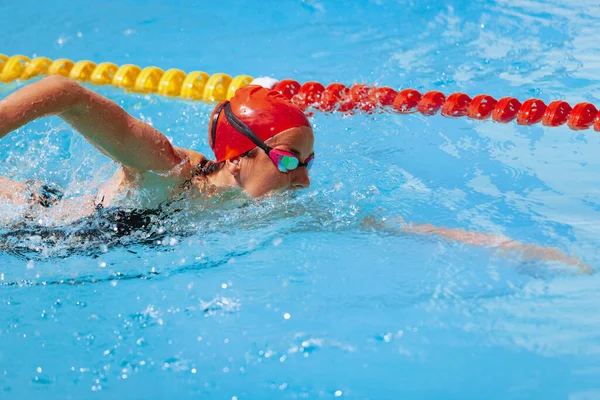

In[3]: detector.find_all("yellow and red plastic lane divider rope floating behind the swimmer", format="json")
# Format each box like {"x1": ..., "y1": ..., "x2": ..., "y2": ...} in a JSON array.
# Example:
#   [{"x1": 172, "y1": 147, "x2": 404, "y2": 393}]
[{"x1": 0, "y1": 54, "x2": 600, "y2": 131}]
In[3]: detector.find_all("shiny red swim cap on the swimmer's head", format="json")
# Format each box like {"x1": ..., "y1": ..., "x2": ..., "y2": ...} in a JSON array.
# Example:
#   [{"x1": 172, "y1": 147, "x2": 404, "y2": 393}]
[{"x1": 208, "y1": 85, "x2": 310, "y2": 162}]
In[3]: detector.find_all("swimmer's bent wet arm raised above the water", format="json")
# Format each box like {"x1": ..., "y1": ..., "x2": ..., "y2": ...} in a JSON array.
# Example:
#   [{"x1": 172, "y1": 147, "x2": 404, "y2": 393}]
[{"x1": 0, "y1": 75, "x2": 187, "y2": 174}]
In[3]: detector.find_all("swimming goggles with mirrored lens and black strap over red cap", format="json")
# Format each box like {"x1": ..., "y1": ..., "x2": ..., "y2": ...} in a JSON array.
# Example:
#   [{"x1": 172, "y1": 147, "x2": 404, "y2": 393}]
[{"x1": 211, "y1": 101, "x2": 315, "y2": 172}]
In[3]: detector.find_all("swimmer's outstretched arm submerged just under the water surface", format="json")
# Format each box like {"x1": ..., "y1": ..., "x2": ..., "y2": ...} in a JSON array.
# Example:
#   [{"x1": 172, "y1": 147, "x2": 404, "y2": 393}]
[{"x1": 363, "y1": 217, "x2": 594, "y2": 275}]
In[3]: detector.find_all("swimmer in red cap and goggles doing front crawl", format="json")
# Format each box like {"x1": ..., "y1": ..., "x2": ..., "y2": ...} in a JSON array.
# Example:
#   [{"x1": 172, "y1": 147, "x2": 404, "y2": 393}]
[{"x1": 0, "y1": 75, "x2": 591, "y2": 272}]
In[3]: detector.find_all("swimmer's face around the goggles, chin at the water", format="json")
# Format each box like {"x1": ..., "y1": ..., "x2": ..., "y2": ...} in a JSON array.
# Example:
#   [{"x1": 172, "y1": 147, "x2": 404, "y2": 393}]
[{"x1": 238, "y1": 126, "x2": 315, "y2": 197}]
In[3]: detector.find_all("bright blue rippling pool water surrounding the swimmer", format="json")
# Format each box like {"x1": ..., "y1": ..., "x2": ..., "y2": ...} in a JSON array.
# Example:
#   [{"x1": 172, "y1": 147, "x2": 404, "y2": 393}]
[{"x1": 0, "y1": 0, "x2": 600, "y2": 400}]
